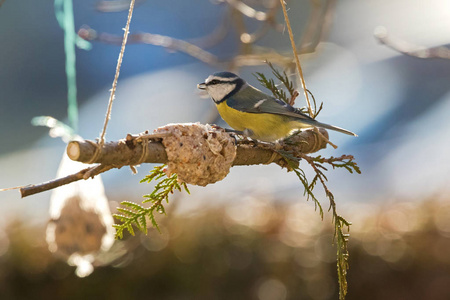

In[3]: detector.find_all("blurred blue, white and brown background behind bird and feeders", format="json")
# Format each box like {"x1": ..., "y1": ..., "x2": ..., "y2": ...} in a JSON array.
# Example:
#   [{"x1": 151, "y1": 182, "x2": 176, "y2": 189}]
[{"x1": 0, "y1": 0, "x2": 450, "y2": 300}]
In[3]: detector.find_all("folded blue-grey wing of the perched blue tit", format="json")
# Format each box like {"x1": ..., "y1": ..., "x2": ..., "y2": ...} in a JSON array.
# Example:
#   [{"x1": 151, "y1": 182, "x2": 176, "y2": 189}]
[{"x1": 227, "y1": 86, "x2": 315, "y2": 122}]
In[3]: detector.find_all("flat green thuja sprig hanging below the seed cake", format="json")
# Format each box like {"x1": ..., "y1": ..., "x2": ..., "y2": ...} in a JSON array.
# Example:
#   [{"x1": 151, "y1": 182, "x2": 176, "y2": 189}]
[{"x1": 113, "y1": 165, "x2": 189, "y2": 239}]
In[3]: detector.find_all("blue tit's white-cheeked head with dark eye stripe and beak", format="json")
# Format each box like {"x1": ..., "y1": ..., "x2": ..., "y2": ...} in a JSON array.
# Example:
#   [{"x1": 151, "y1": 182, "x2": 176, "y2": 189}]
[{"x1": 197, "y1": 72, "x2": 246, "y2": 103}]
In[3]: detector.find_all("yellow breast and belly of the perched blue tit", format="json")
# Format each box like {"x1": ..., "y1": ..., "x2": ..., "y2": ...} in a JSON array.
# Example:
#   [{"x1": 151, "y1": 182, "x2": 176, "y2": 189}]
[{"x1": 216, "y1": 101, "x2": 300, "y2": 142}]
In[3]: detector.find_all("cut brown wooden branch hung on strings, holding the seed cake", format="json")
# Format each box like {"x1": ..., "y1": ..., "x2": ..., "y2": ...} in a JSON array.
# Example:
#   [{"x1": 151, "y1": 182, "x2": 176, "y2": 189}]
[{"x1": 19, "y1": 128, "x2": 328, "y2": 197}]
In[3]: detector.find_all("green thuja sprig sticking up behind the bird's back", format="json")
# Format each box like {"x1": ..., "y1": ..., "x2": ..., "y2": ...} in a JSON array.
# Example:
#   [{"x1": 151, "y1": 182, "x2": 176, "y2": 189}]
[{"x1": 254, "y1": 61, "x2": 323, "y2": 118}]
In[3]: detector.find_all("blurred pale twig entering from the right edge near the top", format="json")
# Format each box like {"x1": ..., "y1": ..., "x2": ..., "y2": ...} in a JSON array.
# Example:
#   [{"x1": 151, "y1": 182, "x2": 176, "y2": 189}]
[{"x1": 374, "y1": 26, "x2": 450, "y2": 59}]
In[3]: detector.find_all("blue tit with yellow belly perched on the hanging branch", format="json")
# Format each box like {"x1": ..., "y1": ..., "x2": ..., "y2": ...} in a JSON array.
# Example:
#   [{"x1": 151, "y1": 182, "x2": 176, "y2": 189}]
[{"x1": 197, "y1": 72, "x2": 357, "y2": 142}]
